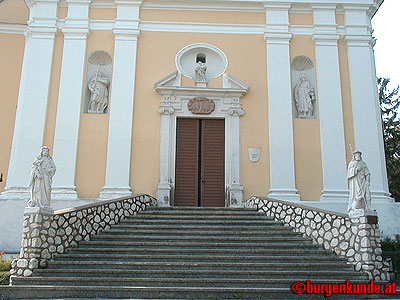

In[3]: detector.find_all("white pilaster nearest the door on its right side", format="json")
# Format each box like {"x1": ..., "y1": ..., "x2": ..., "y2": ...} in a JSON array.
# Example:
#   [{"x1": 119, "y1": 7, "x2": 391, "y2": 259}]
[{"x1": 265, "y1": 4, "x2": 300, "y2": 201}]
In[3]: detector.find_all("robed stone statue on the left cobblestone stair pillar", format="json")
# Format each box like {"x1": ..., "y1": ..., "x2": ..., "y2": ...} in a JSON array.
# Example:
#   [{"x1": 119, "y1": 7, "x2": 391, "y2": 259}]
[{"x1": 28, "y1": 146, "x2": 56, "y2": 208}]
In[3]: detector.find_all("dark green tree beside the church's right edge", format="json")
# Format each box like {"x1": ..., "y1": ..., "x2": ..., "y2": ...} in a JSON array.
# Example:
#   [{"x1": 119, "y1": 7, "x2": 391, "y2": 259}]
[{"x1": 378, "y1": 78, "x2": 400, "y2": 202}]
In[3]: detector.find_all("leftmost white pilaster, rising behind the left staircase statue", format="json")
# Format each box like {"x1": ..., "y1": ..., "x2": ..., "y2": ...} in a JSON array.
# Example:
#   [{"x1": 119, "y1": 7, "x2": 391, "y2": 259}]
[{"x1": 1, "y1": 0, "x2": 58, "y2": 200}]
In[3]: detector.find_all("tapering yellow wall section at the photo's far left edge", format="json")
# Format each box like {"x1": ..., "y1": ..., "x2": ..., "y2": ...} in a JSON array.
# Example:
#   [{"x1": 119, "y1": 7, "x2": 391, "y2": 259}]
[{"x1": 0, "y1": 32, "x2": 25, "y2": 192}]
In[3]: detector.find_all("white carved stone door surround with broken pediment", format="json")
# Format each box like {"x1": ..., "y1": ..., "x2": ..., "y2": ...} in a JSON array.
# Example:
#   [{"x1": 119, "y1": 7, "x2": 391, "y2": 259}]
[{"x1": 155, "y1": 72, "x2": 249, "y2": 207}]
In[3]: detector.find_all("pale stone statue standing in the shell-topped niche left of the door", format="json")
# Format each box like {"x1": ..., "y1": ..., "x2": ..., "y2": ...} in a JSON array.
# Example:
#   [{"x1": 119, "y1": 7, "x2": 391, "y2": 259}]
[{"x1": 88, "y1": 69, "x2": 109, "y2": 114}]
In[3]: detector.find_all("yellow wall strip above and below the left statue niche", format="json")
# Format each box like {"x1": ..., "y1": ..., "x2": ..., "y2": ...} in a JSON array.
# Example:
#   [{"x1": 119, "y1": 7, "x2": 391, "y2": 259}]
[{"x1": 76, "y1": 31, "x2": 114, "y2": 198}]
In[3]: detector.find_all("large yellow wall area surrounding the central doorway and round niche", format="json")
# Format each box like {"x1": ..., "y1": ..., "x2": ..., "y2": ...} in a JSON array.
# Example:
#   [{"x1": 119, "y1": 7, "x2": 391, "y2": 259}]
[{"x1": 131, "y1": 32, "x2": 269, "y2": 197}]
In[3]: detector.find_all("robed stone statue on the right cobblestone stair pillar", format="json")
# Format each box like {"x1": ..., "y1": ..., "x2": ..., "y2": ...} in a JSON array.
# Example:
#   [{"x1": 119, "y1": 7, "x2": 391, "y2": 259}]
[{"x1": 347, "y1": 151, "x2": 372, "y2": 212}]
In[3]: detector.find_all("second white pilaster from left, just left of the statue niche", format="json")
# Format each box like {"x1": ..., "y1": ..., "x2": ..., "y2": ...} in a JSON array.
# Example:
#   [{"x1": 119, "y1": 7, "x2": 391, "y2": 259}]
[{"x1": 52, "y1": 0, "x2": 91, "y2": 199}]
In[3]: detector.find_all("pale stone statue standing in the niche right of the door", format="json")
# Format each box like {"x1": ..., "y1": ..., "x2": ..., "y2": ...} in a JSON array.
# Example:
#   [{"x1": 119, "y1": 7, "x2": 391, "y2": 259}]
[{"x1": 294, "y1": 73, "x2": 315, "y2": 118}]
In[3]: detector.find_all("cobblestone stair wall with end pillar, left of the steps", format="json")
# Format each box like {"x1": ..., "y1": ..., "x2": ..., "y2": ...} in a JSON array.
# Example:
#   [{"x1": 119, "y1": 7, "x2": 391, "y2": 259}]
[{"x1": 10, "y1": 195, "x2": 157, "y2": 276}]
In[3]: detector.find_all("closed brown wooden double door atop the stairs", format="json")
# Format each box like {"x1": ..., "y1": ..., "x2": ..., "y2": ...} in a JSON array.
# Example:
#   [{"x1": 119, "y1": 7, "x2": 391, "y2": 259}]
[{"x1": 174, "y1": 118, "x2": 225, "y2": 207}]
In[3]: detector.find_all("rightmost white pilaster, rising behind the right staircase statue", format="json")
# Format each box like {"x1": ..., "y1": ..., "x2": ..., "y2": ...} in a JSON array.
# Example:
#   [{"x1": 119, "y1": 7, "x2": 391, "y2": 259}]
[{"x1": 344, "y1": 6, "x2": 393, "y2": 205}]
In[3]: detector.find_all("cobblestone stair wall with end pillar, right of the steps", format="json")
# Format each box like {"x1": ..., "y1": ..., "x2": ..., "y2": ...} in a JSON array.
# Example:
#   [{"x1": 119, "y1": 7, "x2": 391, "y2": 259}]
[{"x1": 246, "y1": 197, "x2": 390, "y2": 281}]
